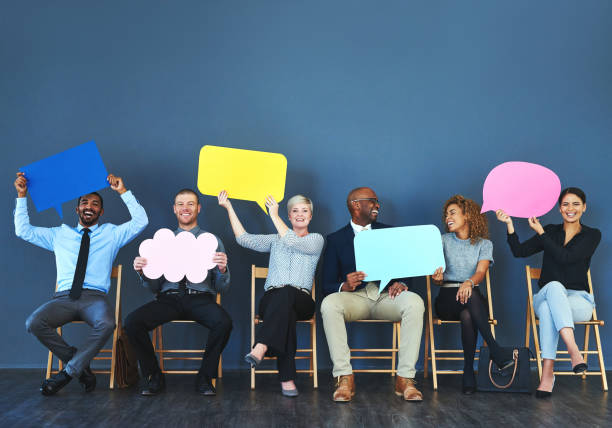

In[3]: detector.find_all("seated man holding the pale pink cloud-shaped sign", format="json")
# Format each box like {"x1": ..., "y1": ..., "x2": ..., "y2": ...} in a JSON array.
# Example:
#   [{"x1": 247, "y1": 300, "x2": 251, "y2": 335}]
[{"x1": 125, "y1": 189, "x2": 232, "y2": 395}]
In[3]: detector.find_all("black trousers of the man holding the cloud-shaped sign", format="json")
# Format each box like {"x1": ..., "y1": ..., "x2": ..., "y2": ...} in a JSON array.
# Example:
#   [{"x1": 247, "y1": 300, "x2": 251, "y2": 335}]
[{"x1": 125, "y1": 293, "x2": 232, "y2": 378}]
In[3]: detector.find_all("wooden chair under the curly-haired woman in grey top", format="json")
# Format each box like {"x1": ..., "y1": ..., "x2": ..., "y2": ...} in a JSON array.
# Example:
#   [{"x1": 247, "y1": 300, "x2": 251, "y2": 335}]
[{"x1": 423, "y1": 270, "x2": 497, "y2": 390}]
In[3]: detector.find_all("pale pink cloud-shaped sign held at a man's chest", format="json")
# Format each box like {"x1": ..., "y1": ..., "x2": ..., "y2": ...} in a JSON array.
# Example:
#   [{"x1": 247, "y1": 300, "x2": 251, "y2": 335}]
[{"x1": 138, "y1": 229, "x2": 218, "y2": 283}]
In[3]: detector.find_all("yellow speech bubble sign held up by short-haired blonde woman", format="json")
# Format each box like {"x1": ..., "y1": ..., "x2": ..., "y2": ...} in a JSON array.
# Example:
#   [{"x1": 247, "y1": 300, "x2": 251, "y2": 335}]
[{"x1": 198, "y1": 146, "x2": 287, "y2": 213}]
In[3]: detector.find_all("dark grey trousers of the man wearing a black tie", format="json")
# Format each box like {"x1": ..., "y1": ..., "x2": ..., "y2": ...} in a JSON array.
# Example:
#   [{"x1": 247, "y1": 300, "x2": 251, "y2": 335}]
[{"x1": 26, "y1": 289, "x2": 115, "y2": 377}]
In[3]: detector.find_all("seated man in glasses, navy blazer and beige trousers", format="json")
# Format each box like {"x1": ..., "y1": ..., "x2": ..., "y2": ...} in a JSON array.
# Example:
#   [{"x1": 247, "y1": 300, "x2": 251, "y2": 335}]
[{"x1": 321, "y1": 187, "x2": 425, "y2": 401}]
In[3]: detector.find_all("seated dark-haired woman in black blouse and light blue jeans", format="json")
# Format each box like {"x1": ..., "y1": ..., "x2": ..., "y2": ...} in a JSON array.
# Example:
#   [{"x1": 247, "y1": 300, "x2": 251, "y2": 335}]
[{"x1": 496, "y1": 187, "x2": 601, "y2": 398}]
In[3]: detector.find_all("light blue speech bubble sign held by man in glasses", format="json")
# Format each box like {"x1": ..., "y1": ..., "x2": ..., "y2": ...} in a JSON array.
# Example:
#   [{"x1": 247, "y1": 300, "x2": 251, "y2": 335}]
[{"x1": 354, "y1": 224, "x2": 446, "y2": 291}]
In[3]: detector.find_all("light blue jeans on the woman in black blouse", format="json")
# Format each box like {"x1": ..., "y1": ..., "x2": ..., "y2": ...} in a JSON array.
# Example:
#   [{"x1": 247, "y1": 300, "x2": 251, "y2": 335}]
[{"x1": 533, "y1": 281, "x2": 595, "y2": 360}]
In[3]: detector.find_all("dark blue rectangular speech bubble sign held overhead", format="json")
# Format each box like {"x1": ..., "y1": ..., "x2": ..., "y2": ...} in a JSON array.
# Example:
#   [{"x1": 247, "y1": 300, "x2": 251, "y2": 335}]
[{"x1": 19, "y1": 140, "x2": 108, "y2": 218}]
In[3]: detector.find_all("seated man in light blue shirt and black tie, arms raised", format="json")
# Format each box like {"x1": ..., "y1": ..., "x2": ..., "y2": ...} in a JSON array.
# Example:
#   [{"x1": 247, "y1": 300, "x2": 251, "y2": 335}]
[{"x1": 15, "y1": 172, "x2": 148, "y2": 395}]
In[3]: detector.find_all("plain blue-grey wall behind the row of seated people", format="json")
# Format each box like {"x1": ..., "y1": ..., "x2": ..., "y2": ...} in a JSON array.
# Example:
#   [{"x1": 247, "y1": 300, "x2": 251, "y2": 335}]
[{"x1": 0, "y1": 0, "x2": 612, "y2": 369}]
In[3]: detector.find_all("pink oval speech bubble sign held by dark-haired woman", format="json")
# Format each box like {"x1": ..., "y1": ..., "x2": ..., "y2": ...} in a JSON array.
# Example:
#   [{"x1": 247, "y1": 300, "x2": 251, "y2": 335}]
[{"x1": 480, "y1": 162, "x2": 561, "y2": 218}]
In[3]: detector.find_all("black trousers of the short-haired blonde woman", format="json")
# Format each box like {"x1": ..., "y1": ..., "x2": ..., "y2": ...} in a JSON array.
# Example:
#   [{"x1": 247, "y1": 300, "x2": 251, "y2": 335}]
[{"x1": 255, "y1": 285, "x2": 315, "y2": 382}]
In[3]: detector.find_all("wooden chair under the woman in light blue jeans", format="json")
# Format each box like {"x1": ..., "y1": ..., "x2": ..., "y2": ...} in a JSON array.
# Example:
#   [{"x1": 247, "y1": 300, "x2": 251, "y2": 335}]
[{"x1": 525, "y1": 265, "x2": 608, "y2": 391}]
